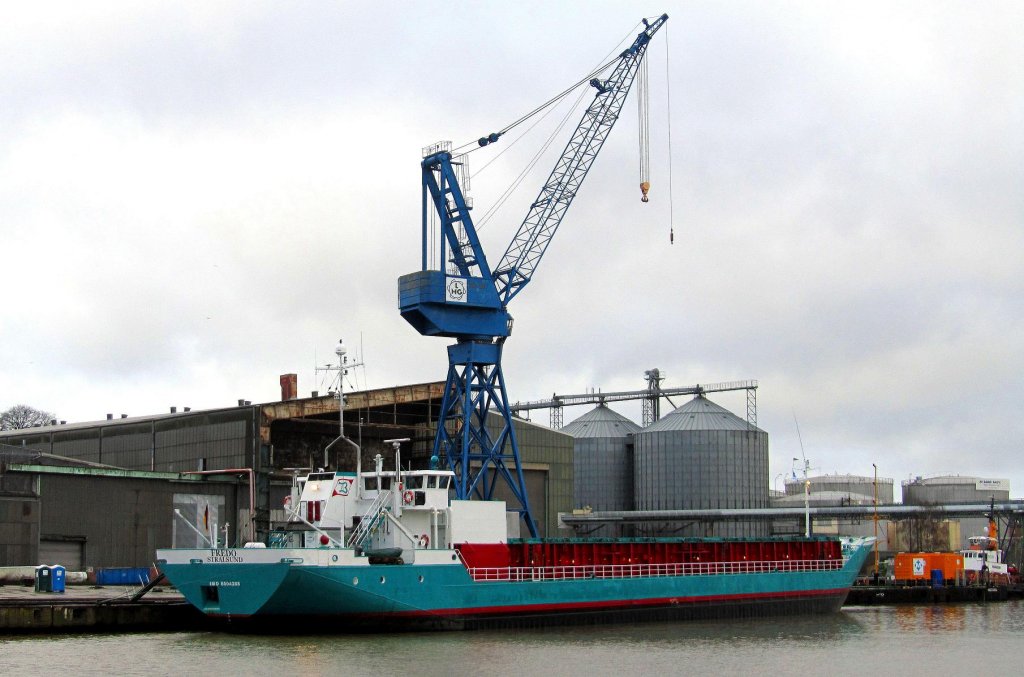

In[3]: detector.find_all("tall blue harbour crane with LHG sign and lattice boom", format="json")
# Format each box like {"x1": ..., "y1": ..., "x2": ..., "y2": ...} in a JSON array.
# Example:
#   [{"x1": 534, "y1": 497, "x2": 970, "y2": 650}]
[{"x1": 398, "y1": 14, "x2": 669, "y2": 537}]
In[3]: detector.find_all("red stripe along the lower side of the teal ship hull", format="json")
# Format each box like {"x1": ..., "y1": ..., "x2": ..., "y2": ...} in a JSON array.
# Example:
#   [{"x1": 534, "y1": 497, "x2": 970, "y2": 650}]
[{"x1": 385, "y1": 588, "x2": 848, "y2": 618}]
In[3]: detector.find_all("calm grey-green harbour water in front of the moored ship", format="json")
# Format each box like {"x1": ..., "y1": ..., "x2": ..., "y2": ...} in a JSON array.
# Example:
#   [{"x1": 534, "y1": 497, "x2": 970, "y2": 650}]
[{"x1": 0, "y1": 600, "x2": 1024, "y2": 677}]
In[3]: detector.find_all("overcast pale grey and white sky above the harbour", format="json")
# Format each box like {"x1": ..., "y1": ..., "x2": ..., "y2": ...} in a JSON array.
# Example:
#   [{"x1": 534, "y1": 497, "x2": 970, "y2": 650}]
[{"x1": 0, "y1": 0, "x2": 1024, "y2": 499}]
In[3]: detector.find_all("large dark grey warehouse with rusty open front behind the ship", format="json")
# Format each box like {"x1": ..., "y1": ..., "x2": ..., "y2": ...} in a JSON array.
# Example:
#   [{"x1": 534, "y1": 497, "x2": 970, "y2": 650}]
[{"x1": 0, "y1": 375, "x2": 572, "y2": 566}]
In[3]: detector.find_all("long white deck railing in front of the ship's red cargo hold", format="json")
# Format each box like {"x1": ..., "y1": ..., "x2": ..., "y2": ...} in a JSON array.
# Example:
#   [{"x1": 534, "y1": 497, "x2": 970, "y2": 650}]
[{"x1": 469, "y1": 559, "x2": 843, "y2": 581}]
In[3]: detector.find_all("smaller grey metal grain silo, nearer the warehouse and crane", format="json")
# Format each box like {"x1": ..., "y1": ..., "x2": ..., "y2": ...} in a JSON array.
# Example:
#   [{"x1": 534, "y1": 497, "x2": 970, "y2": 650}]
[{"x1": 561, "y1": 405, "x2": 640, "y2": 511}]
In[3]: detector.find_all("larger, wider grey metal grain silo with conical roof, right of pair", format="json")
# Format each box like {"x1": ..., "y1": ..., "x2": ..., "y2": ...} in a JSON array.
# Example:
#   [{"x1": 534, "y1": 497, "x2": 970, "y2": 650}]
[{"x1": 633, "y1": 394, "x2": 768, "y2": 536}]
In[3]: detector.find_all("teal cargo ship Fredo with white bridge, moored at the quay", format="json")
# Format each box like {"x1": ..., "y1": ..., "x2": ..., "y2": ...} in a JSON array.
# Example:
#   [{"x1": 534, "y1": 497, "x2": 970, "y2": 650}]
[{"x1": 157, "y1": 456, "x2": 871, "y2": 632}]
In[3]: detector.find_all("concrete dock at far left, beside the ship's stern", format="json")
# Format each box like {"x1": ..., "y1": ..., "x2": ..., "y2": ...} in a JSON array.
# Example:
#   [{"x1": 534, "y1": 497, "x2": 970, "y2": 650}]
[{"x1": 0, "y1": 585, "x2": 208, "y2": 634}]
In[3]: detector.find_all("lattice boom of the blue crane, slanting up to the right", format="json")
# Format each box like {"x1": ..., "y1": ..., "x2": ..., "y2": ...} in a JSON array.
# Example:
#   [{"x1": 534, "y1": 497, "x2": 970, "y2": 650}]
[{"x1": 494, "y1": 14, "x2": 669, "y2": 305}]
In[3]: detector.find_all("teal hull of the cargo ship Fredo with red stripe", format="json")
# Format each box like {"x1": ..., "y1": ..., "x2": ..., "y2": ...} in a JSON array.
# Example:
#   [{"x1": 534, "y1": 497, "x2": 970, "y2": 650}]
[{"x1": 158, "y1": 547, "x2": 868, "y2": 632}]
